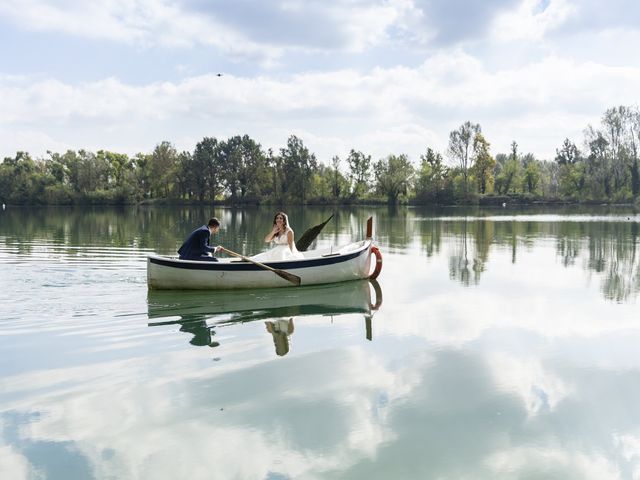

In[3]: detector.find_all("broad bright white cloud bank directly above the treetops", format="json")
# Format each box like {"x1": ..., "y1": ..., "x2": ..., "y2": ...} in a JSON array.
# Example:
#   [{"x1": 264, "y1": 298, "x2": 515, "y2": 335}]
[{"x1": 0, "y1": 52, "x2": 640, "y2": 160}]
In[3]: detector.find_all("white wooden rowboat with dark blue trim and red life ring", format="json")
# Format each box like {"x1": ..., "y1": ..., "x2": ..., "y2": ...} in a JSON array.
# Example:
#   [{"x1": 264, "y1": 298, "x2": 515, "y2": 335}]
[{"x1": 147, "y1": 220, "x2": 382, "y2": 290}]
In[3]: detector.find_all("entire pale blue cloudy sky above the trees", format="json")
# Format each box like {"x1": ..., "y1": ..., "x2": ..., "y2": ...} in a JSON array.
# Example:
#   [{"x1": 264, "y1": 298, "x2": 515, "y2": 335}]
[{"x1": 0, "y1": 0, "x2": 640, "y2": 163}]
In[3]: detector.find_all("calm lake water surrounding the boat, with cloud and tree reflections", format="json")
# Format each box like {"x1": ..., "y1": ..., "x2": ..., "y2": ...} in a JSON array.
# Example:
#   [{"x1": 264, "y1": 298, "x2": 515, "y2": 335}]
[{"x1": 0, "y1": 207, "x2": 640, "y2": 480}]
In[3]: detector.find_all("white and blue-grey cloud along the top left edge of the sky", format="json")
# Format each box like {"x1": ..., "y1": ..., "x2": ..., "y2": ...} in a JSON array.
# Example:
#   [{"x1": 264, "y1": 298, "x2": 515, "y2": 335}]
[{"x1": 0, "y1": 0, "x2": 411, "y2": 64}]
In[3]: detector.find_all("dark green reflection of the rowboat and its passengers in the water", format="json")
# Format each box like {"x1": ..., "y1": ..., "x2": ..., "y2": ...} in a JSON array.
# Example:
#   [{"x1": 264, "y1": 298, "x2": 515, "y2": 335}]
[{"x1": 147, "y1": 280, "x2": 382, "y2": 356}]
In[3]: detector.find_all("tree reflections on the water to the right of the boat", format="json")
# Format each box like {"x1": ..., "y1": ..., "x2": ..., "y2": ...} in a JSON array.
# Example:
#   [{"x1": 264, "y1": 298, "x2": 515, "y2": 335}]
[{"x1": 416, "y1": 211, "x2": 640, "y2": 301}]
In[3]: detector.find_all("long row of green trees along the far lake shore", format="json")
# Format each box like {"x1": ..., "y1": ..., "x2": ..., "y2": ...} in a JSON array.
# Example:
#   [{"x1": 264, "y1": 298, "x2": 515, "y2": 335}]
[{"x1": 0, "y1": 106, "x2": 640, "y2": 205}]
